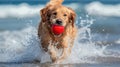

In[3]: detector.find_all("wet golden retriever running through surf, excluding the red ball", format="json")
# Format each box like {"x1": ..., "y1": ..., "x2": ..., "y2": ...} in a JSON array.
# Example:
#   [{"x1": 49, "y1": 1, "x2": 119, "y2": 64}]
[{"x1": 38, "y1": 0, "x2": 77, "y2": 63}]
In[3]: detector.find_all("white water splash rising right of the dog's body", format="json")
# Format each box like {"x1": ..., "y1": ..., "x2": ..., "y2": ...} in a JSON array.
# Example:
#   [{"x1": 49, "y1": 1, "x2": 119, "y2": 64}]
[{"x1": 64, "y1": 15, "x2": 111, "y2": 63}]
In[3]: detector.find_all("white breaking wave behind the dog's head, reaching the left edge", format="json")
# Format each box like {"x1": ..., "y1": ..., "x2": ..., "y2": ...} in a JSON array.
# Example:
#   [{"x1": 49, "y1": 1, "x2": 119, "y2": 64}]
[{"x1": 0, "y1": 3, "x2": 79, "y2": 18}]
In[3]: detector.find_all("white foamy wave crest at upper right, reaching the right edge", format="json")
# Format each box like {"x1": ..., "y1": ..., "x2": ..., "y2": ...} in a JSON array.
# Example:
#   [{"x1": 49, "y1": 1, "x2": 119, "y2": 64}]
[{"x1": 85, "y1": 2, "x2": 120, "y2": 17}]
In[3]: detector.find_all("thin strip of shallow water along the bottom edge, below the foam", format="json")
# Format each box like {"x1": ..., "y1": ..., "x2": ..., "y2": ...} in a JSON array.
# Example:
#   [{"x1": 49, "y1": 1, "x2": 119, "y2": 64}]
[{"x1": 0, "y1": 63, "x2": 120, "y2": 67}]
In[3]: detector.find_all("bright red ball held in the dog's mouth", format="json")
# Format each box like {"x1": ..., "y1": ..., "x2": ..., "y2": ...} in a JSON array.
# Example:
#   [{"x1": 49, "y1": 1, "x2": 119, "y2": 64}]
[{"x1": 52, "y1": 25, "x2": 64, "y2": 35}]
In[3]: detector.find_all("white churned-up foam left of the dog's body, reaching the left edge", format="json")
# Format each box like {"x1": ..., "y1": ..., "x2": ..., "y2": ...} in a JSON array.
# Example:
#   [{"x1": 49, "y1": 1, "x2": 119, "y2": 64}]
[{"x1": 0, "y1": 27, "x2": 40, "y2": 62}]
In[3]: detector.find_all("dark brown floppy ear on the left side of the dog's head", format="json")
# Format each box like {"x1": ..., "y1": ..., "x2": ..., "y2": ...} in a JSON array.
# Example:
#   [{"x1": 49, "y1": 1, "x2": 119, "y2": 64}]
[{"x1": 40, "y1": 7, "x2": 50, "y2": 22}]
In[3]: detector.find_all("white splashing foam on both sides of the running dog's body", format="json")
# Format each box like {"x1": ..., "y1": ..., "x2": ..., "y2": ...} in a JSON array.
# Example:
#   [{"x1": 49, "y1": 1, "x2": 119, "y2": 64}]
[{"x1": 0, "y1": 15, "x2": 120, "y2": 63}]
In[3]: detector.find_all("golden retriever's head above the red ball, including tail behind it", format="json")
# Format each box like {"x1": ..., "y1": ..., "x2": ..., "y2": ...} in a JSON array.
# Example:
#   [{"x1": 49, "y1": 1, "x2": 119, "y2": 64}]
[{"x1": 40, "y1": 0, "x2": 76, "y2": 26}]
